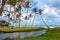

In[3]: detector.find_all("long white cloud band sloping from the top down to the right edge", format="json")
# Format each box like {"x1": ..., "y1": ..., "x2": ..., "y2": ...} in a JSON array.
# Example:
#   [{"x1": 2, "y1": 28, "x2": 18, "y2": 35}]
[{"x1": 36, "y1": 0, "x2": 60, "y2": 17}]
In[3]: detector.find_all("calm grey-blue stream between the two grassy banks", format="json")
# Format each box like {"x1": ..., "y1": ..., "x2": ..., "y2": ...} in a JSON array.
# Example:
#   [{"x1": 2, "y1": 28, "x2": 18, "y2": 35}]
[{"x1": 0, "y1": 30, "x2": 46, "y2": 40}]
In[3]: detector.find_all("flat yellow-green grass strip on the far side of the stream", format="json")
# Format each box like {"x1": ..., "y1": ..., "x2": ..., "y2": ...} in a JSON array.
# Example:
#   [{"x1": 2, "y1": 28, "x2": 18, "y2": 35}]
[{"x1": 0, "y1": 27, "x2": 45, "y2": 33}]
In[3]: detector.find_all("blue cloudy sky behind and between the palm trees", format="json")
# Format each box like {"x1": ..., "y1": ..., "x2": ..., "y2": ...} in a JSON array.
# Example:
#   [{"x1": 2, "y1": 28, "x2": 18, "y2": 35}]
[{"x1": 0, "y1": 0, "x2": 60, "y2": 26}]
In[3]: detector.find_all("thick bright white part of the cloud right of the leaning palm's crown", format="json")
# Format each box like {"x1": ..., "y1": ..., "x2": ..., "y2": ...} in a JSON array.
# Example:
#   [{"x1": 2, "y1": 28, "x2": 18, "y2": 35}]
[{"x1": 43, "y1": 7, "x2": 60, "y2": 17}]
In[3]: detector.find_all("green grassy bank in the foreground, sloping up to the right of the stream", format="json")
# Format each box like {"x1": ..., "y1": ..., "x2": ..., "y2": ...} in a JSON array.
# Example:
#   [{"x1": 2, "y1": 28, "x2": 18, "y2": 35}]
[{"x1": 3, "y1": 27, "x2": 60, "y2": 40}]
